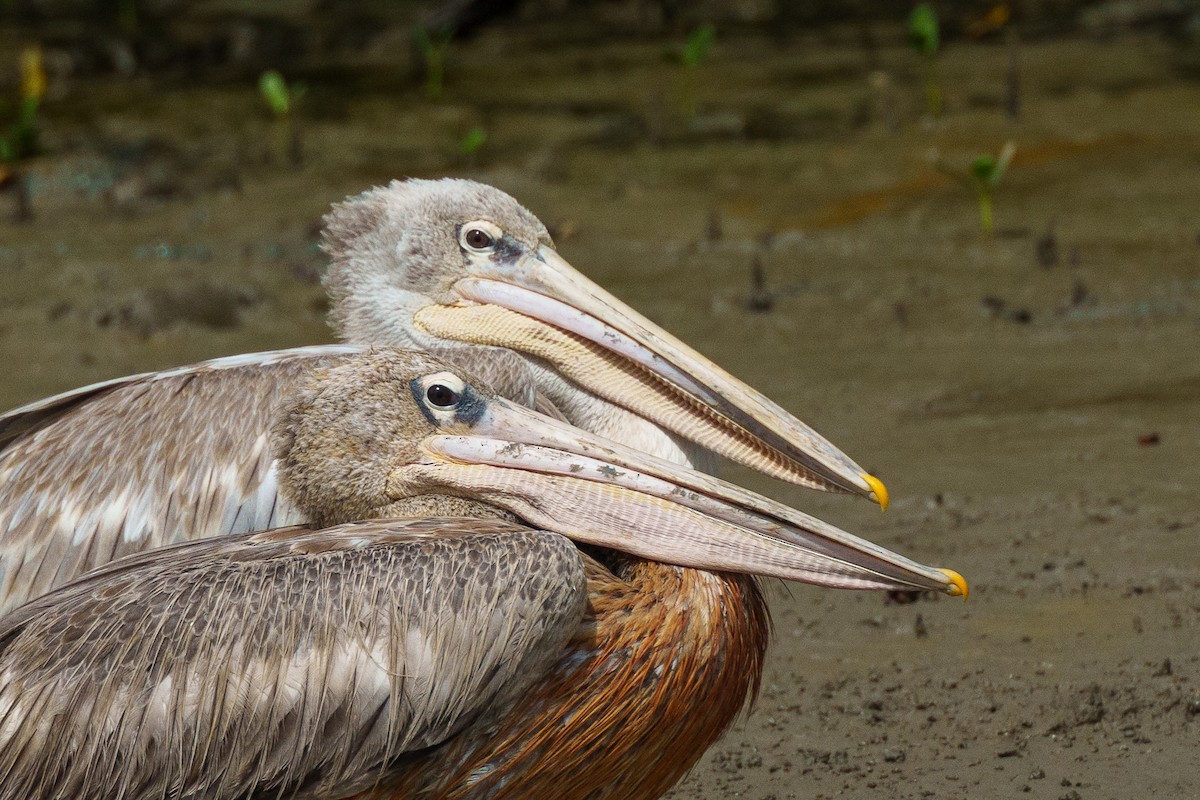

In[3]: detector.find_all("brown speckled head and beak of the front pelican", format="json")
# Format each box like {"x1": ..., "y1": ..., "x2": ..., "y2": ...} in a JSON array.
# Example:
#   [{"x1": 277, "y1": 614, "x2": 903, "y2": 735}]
[{"x1": 276, "y1": 350, "x2": 966, "y2": 595}]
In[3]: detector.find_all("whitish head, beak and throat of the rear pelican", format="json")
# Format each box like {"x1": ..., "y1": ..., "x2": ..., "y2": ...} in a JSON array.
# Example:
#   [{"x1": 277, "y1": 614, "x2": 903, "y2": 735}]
[{"x1": 325, "y1": 179, "x2": 887, "y2": 507}]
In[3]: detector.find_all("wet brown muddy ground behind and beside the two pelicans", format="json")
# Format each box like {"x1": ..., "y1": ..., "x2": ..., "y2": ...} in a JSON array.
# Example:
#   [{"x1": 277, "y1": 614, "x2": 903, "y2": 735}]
[{"x1": 0, "y1": 18, "x2": 1200, "y2": 800}]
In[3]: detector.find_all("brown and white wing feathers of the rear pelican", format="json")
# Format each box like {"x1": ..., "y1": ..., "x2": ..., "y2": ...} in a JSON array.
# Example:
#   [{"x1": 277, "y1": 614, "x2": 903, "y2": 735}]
[{"x1": 0, "y1": 345, "x2": 359, "y2": 612}]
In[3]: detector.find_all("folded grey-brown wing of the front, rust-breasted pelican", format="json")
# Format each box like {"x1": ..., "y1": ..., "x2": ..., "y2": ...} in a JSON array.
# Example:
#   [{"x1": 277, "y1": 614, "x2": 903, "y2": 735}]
[{"x1": 0, "y1": 519, "x2": 587, "y2": 800}]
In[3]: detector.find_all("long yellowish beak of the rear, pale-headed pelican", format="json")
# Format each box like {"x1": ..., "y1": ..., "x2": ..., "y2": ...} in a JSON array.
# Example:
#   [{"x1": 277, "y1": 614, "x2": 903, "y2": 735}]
[{"x1": 414, "y1": 246, "x2": 888, "y2": 509}]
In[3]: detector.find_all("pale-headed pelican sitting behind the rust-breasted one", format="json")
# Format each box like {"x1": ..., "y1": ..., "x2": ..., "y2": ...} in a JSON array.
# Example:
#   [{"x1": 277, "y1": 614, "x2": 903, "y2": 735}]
[{"x1": 0, "y1": 180, "x2": 888, "y2": 612}]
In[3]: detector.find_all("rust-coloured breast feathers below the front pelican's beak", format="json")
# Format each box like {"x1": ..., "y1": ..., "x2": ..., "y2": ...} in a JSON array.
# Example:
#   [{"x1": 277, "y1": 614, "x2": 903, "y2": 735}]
[{"x1": 356, "y1": 560, "x2": 768, "y2": 800}]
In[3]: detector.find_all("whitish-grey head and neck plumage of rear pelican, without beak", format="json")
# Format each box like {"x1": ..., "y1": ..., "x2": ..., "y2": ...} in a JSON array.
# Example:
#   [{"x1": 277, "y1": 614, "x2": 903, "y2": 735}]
[{"x1": 323, "y1": 179, "x2": 676, "y2": 465}]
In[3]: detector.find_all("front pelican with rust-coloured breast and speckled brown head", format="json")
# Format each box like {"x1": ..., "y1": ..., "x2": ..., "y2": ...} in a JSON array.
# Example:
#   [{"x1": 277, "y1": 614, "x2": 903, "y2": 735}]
[{"x1": 0, "y1": 350, "x2": 966, "y2": 800}]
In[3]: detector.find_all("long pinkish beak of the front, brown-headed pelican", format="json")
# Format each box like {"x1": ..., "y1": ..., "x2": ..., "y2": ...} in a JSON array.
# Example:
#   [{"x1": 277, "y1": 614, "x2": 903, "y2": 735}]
[{"x1": 392, "y1": 399, "x2": 967, "y2": 596}]
